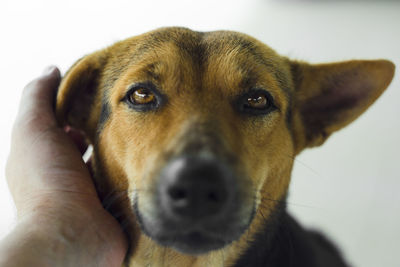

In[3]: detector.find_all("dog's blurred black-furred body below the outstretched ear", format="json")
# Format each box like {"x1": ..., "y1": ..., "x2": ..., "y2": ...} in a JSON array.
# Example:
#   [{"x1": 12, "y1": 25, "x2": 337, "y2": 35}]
[{"x1": 233, "y1": 205, "x2": 348, "y2": 267}]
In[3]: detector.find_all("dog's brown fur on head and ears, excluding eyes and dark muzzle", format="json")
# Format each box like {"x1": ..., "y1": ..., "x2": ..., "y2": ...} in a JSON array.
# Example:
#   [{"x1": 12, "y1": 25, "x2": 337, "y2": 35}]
[{"x1": 57, "y1": 28, "x2": 394, "y2": 267}]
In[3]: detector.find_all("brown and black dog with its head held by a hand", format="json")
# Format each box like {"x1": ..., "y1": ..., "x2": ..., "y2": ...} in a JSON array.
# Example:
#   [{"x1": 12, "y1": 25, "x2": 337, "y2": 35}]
[{"x1": 56, "y1": 27, "x2": 395, "y2": 267}]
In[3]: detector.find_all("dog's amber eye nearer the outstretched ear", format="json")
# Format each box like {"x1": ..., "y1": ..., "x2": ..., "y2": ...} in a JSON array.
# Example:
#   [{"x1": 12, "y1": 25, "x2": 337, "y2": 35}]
[{"x1": 238, "y1": 90, "x2": 275, "y2": 115}]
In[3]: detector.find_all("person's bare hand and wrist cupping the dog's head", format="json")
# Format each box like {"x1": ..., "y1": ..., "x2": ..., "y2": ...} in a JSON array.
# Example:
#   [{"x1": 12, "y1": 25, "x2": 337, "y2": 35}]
[{"x1": 0, "y1": 67, "x2": 127, "y2": 267}]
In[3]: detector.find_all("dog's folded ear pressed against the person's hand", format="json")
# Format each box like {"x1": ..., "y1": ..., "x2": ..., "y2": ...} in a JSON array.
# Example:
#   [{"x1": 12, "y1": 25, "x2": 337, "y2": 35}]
[{"x1": 56, "y1": 51, "x2": 106, "y2": 141}]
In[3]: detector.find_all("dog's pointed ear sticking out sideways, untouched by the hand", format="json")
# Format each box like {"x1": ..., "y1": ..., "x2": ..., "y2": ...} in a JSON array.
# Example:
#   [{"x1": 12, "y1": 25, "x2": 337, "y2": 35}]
[{"x1": 290, "y1": 60, "x2": 395, "y2": 153}]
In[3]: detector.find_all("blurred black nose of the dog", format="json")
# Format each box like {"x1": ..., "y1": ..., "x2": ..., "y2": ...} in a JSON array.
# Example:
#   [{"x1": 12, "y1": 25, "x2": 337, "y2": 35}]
[{"x1": 159, "y1": 156, "x2": 234, "y2": 221}]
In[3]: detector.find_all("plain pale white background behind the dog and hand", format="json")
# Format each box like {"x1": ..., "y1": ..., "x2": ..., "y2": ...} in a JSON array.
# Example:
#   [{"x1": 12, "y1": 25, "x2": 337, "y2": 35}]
[{"x1": 0, "y1": 0, "x2": 400, "y2": 267}]
